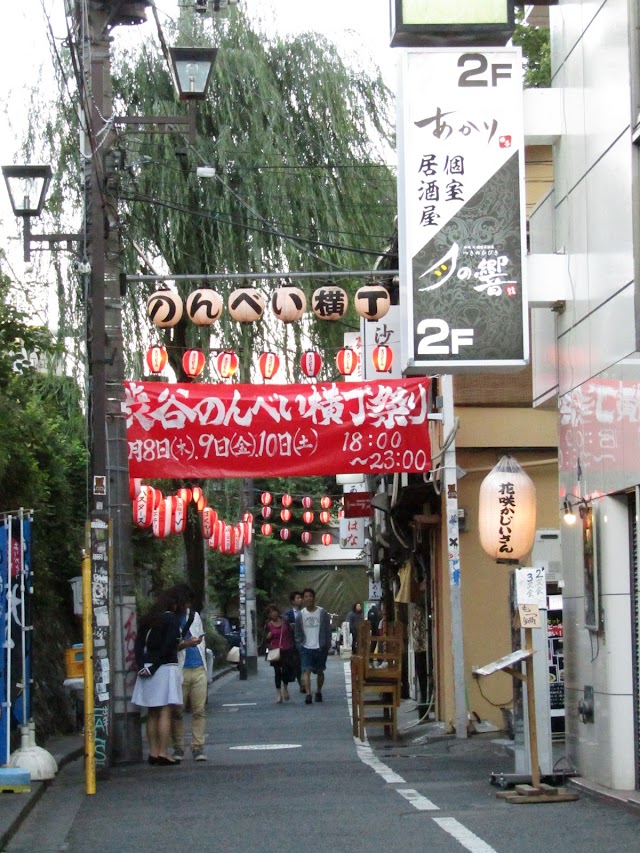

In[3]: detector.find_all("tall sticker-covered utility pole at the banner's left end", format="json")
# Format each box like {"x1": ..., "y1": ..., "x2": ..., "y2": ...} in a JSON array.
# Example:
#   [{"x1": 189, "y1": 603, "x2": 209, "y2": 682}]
[{"x1": 74, "y1": 0, "x2": 148, "y2": 764}]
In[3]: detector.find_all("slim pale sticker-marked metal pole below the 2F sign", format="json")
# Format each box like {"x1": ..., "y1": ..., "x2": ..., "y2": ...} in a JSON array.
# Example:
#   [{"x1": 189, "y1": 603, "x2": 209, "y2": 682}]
[{"x1": 440, "y1": 375, "x2": 468, "y2": 738}]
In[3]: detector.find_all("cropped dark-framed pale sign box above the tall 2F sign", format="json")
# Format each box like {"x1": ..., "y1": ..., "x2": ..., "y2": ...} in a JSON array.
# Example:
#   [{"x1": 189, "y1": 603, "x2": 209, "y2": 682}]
[{"x1": 389, "y1": 0, "x2": 515, "y2": 47}]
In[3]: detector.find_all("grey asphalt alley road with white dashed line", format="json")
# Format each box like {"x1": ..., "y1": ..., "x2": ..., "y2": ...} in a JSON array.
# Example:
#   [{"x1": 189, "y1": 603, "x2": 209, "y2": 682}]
[{"x1": 6, "y1": 658, "x2": 640, "y2": 853}]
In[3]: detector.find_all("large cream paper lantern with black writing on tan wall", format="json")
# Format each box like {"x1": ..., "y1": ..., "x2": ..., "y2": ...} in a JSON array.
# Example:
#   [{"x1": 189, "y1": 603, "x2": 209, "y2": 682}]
[{"x1": 478, "y1": 456, "x2": 536, "y2": 563}]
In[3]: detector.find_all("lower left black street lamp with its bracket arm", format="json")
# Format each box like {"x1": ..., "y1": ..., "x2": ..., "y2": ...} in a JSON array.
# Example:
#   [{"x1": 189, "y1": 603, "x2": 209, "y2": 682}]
[{"x1": 2, "y1": 165, "x2": 80, "y2": 262}]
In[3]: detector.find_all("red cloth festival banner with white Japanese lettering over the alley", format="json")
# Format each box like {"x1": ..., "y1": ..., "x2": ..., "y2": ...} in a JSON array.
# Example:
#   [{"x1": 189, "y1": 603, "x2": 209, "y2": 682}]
[{"x1": 124, "y1": 377, "x2": 431, "y2": 479}]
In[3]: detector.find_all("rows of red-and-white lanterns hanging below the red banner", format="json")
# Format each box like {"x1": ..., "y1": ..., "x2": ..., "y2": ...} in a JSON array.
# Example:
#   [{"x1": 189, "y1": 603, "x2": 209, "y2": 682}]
[{"x1": 129, "y1": 479, "x2": 340, "y2": 544}]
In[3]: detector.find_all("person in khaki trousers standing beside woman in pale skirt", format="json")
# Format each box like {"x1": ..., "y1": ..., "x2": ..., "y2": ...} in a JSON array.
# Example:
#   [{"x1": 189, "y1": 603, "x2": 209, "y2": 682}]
[{"x1": 171, "y1": 583, "x2": 207, "y2": 761}]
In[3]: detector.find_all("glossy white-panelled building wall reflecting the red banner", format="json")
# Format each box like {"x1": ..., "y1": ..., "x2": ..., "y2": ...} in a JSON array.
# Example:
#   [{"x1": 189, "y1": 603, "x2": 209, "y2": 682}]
[{"x1": 531, "y1": 0, "x2": 640, "y2": 789}]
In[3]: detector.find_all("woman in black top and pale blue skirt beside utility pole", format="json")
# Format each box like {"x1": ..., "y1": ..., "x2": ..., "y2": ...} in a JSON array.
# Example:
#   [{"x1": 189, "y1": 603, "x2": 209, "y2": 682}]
[{"x1": 131, "y1": 590, "x2": 196, "y2": 767}]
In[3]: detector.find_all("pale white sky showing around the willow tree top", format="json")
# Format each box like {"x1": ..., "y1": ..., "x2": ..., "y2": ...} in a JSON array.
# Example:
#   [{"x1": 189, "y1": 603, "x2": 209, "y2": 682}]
[{"x1": 0, "y1": 0, "x2": 395, "y2": 286}]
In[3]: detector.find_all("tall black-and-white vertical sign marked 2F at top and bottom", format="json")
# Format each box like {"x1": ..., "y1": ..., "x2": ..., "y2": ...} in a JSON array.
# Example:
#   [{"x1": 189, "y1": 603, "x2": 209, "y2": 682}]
[{"x1": 398, "y1": 48, "x2": 529, "y2": 375}]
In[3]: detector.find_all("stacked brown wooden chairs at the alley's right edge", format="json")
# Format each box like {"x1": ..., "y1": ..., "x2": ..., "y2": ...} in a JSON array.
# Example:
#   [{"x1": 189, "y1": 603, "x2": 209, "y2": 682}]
[{"x1": 351, "y1": 620, "x2": 403, "y2": 740}]
